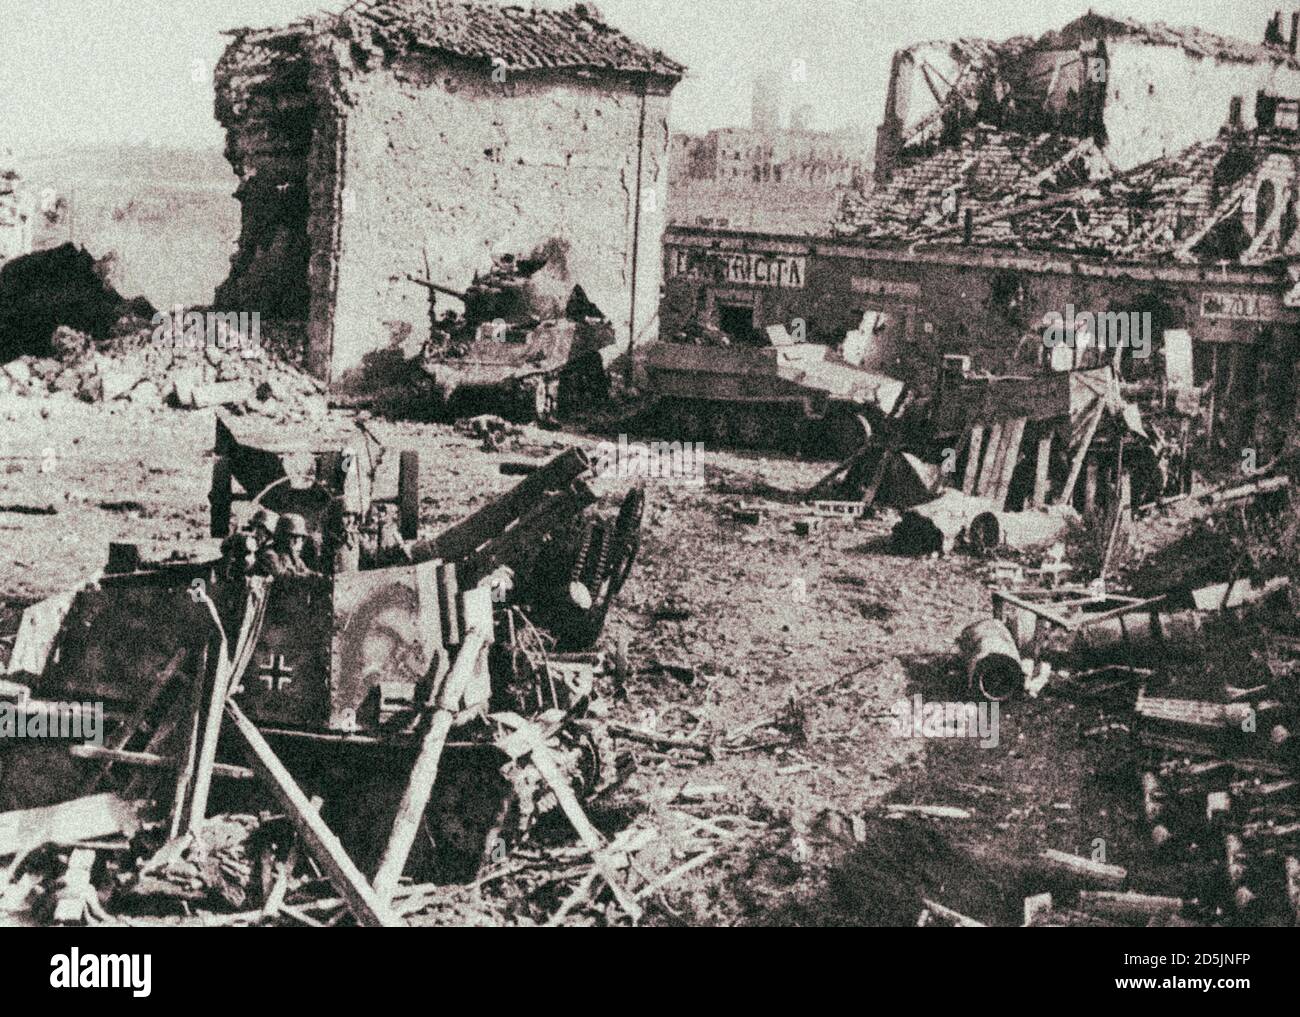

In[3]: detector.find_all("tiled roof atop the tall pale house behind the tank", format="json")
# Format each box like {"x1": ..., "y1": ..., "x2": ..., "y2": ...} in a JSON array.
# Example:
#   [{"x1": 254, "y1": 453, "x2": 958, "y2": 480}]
[{"x1": 348, "y1": 0, "x2": 685, "y2": 78}]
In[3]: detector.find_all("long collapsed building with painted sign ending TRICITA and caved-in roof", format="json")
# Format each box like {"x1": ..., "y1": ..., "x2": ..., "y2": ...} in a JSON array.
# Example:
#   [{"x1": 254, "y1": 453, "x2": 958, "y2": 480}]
[{"x1": 660, "y1": 9, "x2": 1300, "y2": 456}]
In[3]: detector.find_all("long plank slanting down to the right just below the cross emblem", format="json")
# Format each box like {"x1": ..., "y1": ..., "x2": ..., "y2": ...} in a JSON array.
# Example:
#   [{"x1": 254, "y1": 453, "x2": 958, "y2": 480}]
[{"x1": 226, "y1": 700, "x2": 406, "y2": 927}]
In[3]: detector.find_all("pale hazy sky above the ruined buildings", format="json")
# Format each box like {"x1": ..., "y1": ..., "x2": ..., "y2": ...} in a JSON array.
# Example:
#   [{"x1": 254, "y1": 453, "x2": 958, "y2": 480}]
[{"x1": 0, "y1": 0, "x2": 1286, "y2": 153}]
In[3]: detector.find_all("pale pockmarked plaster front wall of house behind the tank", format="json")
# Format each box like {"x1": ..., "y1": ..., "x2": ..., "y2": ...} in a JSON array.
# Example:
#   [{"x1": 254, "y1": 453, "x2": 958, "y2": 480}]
[{"x1": 321, "y1": 46, "x2": 668, "y2": 390}]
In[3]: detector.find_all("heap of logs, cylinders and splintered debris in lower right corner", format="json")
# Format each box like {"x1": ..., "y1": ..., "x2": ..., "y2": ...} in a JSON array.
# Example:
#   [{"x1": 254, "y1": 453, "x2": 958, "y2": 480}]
[{"x1": 941, "y1": 465, "x2": 1300, "y2": 926}]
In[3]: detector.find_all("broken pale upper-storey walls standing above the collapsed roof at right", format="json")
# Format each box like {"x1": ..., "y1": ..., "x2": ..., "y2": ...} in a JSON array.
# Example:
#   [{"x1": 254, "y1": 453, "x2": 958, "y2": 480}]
[{"x1": 875, "y1": 12, "x2": 1300, "y2": 181}]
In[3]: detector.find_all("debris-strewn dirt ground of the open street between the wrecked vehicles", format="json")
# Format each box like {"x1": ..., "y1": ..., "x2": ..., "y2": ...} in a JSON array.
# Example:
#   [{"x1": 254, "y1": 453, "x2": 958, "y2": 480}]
[{"x1": 0, "y1": 397, "x2": 1145, "y2": 925}]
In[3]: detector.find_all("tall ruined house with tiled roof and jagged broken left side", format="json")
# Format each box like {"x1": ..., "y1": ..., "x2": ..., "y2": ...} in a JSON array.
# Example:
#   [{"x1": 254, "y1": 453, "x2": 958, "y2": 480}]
[{"x1": 216, "y1": 0, "x2": 684, "y2": 385}]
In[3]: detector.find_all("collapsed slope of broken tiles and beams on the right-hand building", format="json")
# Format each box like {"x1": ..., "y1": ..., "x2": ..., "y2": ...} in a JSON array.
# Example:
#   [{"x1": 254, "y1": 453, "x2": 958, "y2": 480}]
[{"x1": 840, "y1": 131, "x2": 1300, "y2": 265}]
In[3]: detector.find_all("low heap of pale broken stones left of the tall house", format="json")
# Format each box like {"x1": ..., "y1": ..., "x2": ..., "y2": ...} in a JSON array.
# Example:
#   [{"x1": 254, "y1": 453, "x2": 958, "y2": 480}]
[{"x1": 0, "y1": 316, "x2": 328, "y2": 420}]
